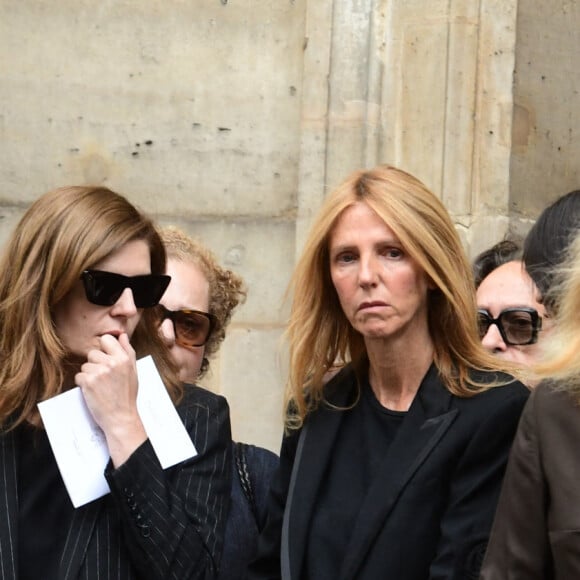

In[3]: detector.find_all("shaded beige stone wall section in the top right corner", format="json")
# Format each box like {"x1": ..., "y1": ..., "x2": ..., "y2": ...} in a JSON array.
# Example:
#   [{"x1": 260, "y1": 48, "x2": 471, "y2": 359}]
[{"x1": 510, "y1": 0, "x2": 580, "y2": 235}]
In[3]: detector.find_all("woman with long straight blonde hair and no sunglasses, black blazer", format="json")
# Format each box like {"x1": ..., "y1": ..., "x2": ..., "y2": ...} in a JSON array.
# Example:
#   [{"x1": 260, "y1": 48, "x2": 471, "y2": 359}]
[{"x1": 249, "y1": 166, "x2": 528, "y2": 580}]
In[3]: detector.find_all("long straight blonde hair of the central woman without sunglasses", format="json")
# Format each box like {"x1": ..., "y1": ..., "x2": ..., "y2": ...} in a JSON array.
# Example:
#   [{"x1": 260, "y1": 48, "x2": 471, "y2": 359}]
[{"x1": 286, "y1": 165, "x2": 513, "y2": 429}]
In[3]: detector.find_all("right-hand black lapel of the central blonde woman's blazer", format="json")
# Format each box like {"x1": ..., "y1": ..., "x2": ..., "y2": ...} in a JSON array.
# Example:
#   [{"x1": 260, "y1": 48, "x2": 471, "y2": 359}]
[{"x1": 340, "y1": 365, "x2": 458, "y2": 580}]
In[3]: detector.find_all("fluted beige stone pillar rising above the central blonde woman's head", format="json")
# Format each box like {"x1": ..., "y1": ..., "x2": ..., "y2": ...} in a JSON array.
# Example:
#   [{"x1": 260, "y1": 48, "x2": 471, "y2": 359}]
[{"x1": 297, "y1": 0, "x2": 517, "y2": 253}]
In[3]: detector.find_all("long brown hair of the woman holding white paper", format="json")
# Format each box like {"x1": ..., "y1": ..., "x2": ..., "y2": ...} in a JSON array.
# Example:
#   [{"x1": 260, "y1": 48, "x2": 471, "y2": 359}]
[{"x1": 0, "y1": 187, "x2": 181, "y2": 428}]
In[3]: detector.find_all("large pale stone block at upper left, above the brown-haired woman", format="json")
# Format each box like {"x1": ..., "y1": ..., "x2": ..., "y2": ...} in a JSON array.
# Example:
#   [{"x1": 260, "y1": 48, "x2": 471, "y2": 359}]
[{"x1": 0, "y1": 0, "x2": 304, "y2": 216}]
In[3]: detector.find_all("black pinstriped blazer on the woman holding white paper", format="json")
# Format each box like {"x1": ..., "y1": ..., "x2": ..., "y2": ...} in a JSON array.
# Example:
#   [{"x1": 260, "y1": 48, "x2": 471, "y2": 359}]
[{"x1": 0, "y1": 385, "x2": 232, "y2": 580}]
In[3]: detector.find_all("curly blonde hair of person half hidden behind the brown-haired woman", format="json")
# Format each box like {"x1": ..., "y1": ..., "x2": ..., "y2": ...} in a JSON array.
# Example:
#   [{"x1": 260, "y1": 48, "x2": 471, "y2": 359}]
[{"x1": 159, "y1": 226, "x2": 247, "y2": 377}]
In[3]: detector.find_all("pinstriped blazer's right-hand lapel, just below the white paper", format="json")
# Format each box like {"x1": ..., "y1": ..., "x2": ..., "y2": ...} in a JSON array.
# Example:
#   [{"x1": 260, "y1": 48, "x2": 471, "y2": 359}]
[{"x1": 59, "y1": 498, "x2": 105, "y2": 580}]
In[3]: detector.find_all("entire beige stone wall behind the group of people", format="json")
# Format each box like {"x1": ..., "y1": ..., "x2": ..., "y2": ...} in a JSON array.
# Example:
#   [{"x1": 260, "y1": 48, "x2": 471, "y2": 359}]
[{"x1": 0, "y1": 0, "x2": 580, "y2": 450}]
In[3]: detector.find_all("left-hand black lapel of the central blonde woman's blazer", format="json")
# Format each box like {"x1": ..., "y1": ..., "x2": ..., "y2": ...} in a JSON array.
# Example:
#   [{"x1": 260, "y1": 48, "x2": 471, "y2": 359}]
[{"x1": 285, "y1": 366, "x2": 356, "y2": 580}]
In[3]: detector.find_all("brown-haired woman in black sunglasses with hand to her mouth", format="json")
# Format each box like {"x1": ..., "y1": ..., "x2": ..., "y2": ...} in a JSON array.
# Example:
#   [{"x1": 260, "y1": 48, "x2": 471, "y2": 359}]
[{"x1": 0, "y1": 187, "x2": 231, "y2": 580}]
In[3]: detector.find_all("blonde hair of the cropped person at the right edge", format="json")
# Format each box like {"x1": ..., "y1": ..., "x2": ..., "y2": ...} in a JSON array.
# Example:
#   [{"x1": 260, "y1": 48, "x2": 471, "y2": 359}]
[{"x1": 534, "y1": 234, "x2": 580, "y2": 394}]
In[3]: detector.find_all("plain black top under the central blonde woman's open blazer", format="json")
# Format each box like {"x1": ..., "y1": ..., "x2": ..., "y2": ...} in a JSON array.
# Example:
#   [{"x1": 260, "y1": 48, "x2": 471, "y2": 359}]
[{"x1": 302, "y1": 383, "x2": 406, "y2": 580}]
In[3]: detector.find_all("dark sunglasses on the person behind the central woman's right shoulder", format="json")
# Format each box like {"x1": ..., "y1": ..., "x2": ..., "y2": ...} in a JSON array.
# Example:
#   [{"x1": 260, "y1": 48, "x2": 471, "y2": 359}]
[{"x1": 477, "y1": 308, "x2": 542, "y2": 346}]
